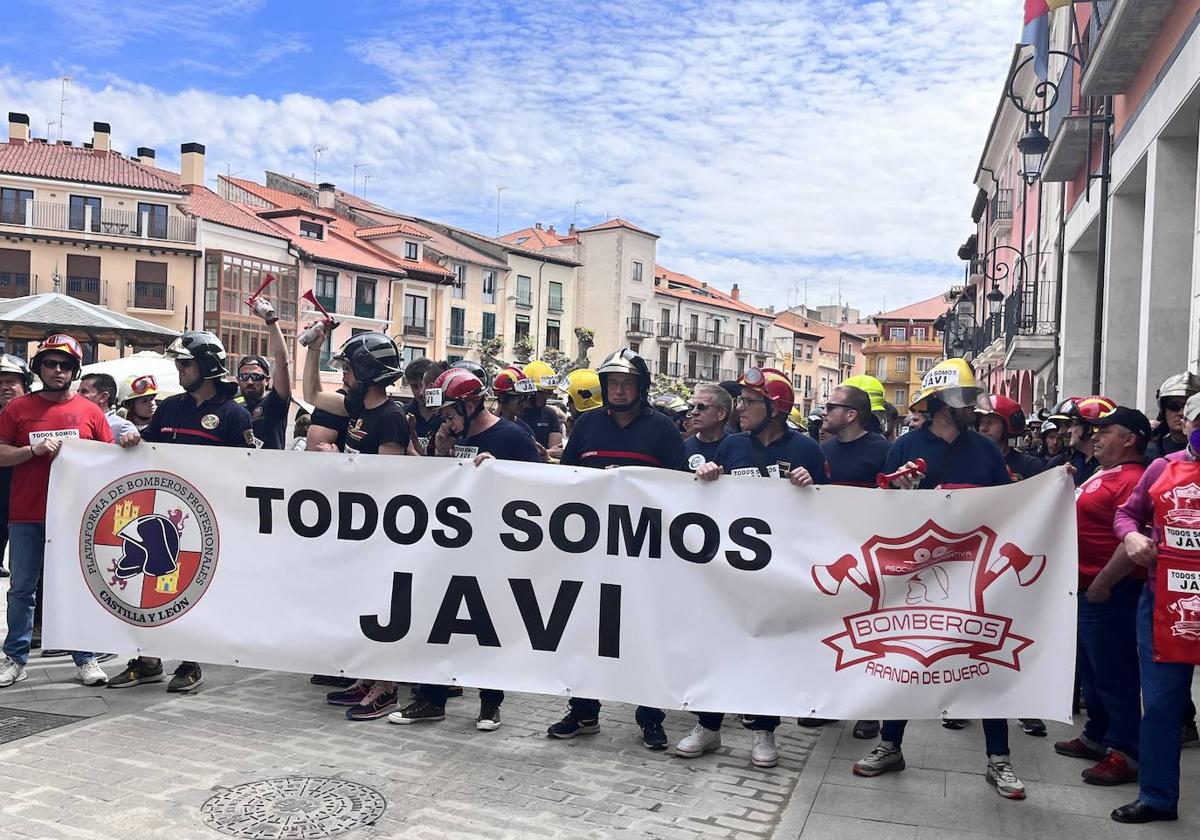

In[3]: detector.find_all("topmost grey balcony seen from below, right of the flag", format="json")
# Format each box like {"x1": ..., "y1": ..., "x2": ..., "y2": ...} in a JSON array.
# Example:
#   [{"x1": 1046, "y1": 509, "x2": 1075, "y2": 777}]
[{"x1": 1080, "y1": 0, "x2": 1178, "y2": 96}]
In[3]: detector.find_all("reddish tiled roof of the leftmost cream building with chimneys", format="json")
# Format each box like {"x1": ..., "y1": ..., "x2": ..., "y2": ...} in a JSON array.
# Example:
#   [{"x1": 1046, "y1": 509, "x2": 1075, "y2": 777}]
[{"x1": 0, "y1": 140, "x2": 184, "y2": 193}]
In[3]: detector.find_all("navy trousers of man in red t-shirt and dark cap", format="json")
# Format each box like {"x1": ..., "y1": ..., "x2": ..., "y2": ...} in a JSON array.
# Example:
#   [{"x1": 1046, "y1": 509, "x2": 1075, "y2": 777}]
[{"x1": 1079, "y1": 577, "x2": 1145, "y2": 761}]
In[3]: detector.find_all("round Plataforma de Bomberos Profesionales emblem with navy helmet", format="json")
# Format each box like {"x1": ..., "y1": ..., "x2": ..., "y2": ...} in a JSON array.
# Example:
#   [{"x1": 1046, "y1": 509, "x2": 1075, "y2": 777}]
[{"x1": 79, "y1": 472, "x2": 220, "y2": 626}]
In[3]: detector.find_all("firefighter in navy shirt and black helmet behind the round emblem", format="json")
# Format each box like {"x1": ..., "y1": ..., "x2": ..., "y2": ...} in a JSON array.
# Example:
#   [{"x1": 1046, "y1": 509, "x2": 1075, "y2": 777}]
[{"x1": 108, "y1": 330, "x2": 254, "y2": 691}]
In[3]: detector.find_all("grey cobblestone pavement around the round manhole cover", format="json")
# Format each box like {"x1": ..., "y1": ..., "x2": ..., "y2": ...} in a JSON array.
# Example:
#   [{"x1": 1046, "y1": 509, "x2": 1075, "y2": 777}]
[{"x1": 0, "y1": 659, "x2": 820, "y2": 840}]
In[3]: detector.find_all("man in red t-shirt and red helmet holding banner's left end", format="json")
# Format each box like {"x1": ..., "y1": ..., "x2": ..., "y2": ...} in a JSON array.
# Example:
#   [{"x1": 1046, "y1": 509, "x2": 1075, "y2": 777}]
[{"x1": 0, "y1": 335, "x2": 113, "y2": 688}]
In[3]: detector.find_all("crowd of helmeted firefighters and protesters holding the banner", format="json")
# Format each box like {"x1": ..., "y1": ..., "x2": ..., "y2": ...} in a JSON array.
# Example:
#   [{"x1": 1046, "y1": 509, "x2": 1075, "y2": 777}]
[{"x1": 0, "y1": 294, "x2": 1200, "y2": 823}]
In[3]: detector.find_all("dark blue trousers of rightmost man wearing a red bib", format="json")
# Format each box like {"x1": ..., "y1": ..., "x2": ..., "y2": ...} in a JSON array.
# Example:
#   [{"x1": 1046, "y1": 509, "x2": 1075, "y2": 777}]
[{"x1": 1138, "y1": 584, "x2": 1195, "y2": 811}]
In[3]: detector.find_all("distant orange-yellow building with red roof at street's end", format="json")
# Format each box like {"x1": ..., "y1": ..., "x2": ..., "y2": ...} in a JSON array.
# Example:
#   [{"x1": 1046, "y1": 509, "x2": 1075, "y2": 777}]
[{"x1": 863, "y1": 295, "x2": 949, "y2": 415}]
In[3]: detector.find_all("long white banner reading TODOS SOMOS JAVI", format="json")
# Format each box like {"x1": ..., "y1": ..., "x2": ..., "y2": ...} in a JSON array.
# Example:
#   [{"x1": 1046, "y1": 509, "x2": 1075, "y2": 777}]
[{"x1": 44, "y1": 442, "x2": 1078, "y2": 720}]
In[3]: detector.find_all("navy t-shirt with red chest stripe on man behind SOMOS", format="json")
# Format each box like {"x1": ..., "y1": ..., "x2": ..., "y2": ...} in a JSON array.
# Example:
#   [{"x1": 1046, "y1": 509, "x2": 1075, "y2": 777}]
[{"x1": 560, "y1": 406, "x2": 688, "y2": 470}]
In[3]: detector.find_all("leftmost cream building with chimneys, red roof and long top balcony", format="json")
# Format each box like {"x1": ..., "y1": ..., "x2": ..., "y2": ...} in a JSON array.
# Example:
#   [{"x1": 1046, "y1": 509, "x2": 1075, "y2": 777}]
[{"x1": 0, "y1": 113, "x2": 204, "y2": 362}]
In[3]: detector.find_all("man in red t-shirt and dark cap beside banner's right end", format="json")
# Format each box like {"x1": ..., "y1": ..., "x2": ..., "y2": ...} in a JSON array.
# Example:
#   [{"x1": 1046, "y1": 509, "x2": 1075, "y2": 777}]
[{"x1": 1054, "y1": 406, "x2": 1151, "y2": 785}]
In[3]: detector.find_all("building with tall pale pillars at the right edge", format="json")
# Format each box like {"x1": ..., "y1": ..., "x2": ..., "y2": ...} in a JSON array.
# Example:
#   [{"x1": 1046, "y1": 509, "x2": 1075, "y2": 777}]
[{"x1": 1043, "y1": 0, "x2": 1200, "y2": 408}]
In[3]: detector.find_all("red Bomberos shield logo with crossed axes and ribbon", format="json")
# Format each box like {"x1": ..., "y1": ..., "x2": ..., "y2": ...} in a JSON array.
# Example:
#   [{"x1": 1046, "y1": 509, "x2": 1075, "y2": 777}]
[{"x1": 812, "y1": 520, "x2": 1045, "y2": 672}]
